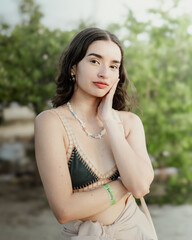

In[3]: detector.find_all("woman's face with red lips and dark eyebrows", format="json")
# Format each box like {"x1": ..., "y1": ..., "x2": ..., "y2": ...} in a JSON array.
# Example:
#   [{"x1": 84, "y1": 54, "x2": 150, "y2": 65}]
[{"x1": 72, "y1": 40, "x2": 121, "y2": 97}]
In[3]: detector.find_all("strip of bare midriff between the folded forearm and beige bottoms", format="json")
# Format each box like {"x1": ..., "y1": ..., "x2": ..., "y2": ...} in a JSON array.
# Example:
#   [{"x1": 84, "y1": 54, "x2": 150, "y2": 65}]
[{"x1": 80, "y1": 193, "x2": 130, "y2": 225}]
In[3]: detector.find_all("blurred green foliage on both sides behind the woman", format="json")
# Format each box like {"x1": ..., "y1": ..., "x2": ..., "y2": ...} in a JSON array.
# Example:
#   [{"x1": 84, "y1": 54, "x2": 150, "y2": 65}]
[{"x1": 0, "y1": 0, "x2": 192, "y2": 203}]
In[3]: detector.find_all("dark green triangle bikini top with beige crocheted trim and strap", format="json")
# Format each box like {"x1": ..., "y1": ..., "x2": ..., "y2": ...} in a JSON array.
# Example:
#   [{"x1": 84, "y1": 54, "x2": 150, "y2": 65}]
[{"x1": 51, "y1": 108, "x2": 119, "y2": 192}]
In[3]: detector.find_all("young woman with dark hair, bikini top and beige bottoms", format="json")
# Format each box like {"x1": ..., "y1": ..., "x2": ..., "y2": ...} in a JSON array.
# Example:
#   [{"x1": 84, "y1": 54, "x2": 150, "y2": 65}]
[{"x1": 35, "y1": 28, "x2": 156, "y2": 240}]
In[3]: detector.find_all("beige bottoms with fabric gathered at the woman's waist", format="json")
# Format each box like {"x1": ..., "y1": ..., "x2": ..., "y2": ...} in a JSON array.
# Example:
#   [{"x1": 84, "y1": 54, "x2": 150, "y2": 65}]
[{"x1": 62, "y1": 195, "x2": 157, "y2": 240}]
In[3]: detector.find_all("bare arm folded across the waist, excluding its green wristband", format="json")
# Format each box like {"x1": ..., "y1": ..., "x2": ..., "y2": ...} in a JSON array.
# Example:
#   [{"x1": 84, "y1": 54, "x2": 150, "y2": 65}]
[{"x1": 35, "y1": 111, "x2": 127, "y2": 224}]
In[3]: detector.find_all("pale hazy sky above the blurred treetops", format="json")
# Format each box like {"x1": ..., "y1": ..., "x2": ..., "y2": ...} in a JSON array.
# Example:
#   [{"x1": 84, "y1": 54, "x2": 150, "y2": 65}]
[{"x1": 0, "y1": 0, "x2": 192, "y2": 30}]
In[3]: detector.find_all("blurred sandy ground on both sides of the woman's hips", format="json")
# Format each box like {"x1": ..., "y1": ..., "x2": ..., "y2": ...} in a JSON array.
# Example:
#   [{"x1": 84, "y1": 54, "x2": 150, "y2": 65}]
[{"x1": 0, "y1": 184, "x2": 192, "y2": 240}]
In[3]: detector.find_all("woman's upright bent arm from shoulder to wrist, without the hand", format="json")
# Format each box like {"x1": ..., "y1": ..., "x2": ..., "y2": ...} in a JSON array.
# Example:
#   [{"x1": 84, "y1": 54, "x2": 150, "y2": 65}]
[{"x1": 104, "y1": 112, "x2": 154, "y2": 198}]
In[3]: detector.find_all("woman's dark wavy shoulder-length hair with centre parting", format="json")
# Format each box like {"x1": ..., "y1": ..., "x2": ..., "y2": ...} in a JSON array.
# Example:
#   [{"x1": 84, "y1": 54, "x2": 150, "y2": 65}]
[{"x1": 51, "y1": 28, "x2": 134, "y2": 110}]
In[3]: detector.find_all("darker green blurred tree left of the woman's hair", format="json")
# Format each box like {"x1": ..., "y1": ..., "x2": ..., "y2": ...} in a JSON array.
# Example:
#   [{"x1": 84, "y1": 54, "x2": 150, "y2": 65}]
[{"x1": 0, "y1": 0, "x2": 75, "y2": 113}]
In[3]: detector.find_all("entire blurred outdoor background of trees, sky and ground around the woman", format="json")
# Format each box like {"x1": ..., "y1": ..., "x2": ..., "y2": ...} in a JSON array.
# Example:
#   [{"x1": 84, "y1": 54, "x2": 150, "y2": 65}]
[{"x1": 0, "y1": 0, "x2": 192, "y2": 240}]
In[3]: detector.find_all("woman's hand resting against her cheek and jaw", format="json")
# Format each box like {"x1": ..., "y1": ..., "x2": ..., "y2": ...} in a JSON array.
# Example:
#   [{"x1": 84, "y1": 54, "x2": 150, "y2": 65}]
[{"x1": 97, "y1": 78, "x2": 120, "y2": 122}]
